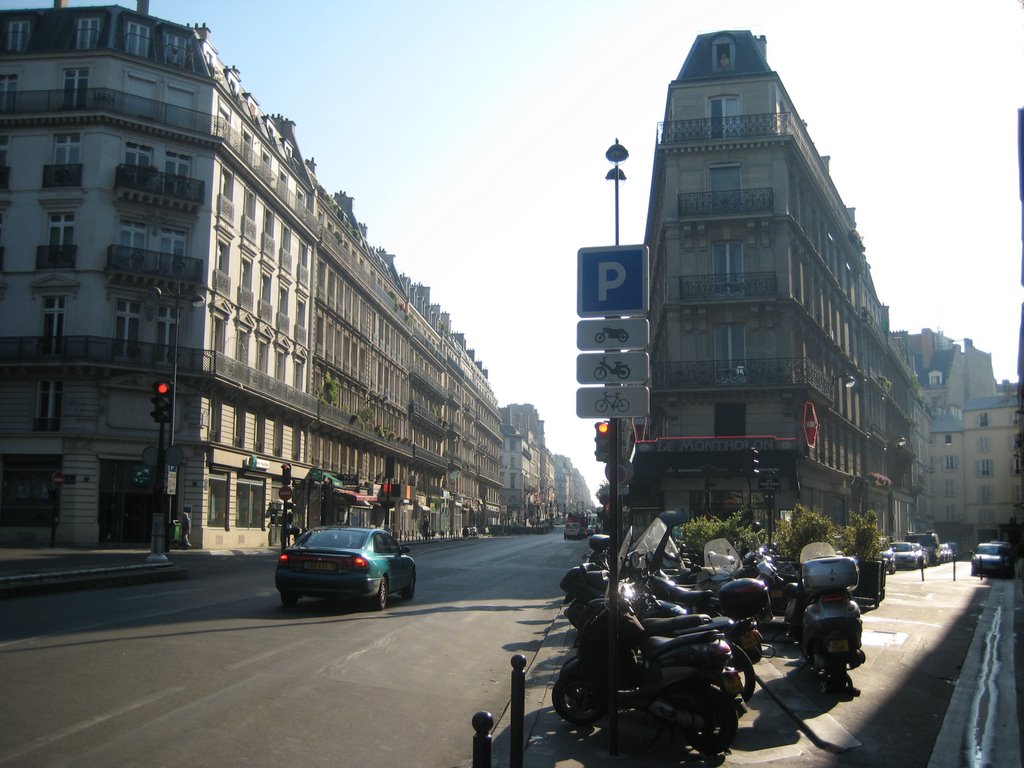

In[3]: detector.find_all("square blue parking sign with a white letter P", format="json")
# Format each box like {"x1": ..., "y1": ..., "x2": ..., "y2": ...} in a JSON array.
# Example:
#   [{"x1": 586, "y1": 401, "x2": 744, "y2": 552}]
[{"x1": 577, "y1": 245, "x2": 650, "y2": 317}]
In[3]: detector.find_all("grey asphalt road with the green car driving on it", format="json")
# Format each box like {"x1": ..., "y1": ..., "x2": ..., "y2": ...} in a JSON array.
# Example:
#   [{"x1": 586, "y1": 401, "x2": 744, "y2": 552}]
[{"x1": 0, "y1": 536, "x2": 579, "y2": 767}]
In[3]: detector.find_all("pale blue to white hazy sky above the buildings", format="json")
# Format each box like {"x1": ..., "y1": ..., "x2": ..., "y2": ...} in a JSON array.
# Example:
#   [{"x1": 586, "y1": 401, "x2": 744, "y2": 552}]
[{"x1": 9, "y1": 0, "x2": 1024, "y2": 501}]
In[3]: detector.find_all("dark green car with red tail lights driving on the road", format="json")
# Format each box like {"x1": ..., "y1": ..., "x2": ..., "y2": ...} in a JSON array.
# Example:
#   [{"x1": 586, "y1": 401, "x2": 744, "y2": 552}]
[{"x1": 274, "y1": 525, "x2": 416, "y2": 610}]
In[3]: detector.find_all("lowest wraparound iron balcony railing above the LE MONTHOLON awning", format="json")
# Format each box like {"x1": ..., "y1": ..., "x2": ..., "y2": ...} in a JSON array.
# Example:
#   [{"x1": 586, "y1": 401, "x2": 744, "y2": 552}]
[{"x1": 651, "y1": 357, "x2": 831, "y2": 394}]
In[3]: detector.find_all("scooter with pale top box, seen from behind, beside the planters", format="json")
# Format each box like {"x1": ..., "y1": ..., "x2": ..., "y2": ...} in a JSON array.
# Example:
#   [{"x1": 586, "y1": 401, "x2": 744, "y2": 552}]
[{"x1": 784, "y1": 542, "x2": 864, "y2": 695}]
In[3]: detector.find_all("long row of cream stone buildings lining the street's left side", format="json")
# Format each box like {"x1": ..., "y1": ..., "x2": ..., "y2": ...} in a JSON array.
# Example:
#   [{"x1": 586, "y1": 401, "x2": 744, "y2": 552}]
[{"x1": 0, "y1": 2, "x2": 502, "y2": 548}]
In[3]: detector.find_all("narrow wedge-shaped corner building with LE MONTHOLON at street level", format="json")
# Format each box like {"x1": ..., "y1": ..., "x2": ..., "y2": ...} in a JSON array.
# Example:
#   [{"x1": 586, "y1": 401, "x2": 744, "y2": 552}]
[{"x1": 630, "y1": 32, "x2": 928, "y2": 532}]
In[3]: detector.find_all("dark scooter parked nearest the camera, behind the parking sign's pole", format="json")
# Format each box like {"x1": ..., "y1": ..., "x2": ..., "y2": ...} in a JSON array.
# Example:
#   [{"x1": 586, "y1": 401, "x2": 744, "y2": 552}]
[{"x1": 552, "y1": 512, "x2": 741, "y2": 755}]
